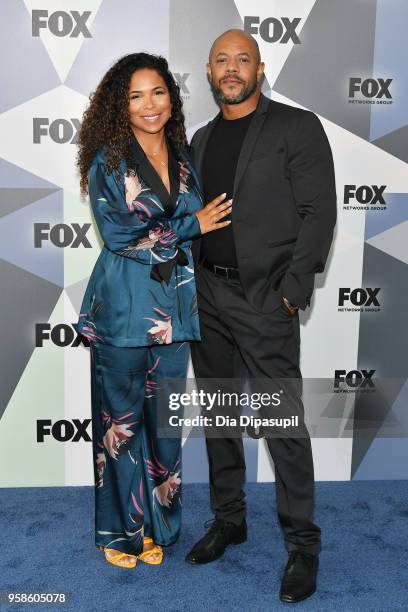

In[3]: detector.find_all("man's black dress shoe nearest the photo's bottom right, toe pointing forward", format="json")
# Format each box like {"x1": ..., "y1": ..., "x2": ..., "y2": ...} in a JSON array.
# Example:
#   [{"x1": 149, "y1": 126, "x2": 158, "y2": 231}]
[{"x1": 279, "y1": 550, "x2": 319, "y2": 603}]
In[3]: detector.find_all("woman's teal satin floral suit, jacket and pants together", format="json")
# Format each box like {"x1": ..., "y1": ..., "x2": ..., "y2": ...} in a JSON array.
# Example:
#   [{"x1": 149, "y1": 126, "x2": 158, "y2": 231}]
[{"x1": 78, "y1": 138, "x2": 202, "y2": 555}]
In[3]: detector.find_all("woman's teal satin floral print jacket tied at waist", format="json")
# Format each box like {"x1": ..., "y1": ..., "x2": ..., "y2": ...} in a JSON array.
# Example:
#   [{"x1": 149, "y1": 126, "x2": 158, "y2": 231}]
[{"x1": 78, "y1": 139, "x2": 203, "y2": 347}]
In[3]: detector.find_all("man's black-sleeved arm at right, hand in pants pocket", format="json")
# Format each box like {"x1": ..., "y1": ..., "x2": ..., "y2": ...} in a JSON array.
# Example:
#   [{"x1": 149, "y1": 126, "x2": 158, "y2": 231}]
[{"x1": 282, "y1": 112, "x2": 336, "y2": 310}]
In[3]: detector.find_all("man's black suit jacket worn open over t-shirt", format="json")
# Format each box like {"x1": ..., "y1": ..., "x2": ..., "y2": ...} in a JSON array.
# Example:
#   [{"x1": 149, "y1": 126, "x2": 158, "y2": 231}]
[{"x1": 191, "y1": 94, "x2": 336, "y2": 313}]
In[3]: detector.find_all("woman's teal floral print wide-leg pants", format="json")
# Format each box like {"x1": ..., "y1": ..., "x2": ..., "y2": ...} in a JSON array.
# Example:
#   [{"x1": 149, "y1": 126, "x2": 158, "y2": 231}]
[{"x1": 91, "y1": 342, "x2": 189, "y2": 555}]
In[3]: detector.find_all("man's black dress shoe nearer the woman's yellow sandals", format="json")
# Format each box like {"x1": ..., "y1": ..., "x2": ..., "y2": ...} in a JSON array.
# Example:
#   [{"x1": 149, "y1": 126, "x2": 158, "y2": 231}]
[{"x1": 186, "y1": 519, "x2": 247, "y2": 565}]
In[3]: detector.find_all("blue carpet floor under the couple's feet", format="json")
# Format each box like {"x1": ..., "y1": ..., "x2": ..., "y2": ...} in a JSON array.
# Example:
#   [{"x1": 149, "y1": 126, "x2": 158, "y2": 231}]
[{"x1": 0, "y1": 481, "x2": 408, "y2": 612}]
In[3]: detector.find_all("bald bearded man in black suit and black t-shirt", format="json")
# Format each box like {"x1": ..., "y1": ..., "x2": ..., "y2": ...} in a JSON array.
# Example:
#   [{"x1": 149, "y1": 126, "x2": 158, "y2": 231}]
[{"x1": 186, "y1": 30, "x2": 336, "y2": 602}]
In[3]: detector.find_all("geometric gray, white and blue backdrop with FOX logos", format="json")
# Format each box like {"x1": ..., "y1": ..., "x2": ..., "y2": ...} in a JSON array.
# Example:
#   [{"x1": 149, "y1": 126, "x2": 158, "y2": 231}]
[{"x1": 0, "y1": 0, "x2": 408, "y2": 487}]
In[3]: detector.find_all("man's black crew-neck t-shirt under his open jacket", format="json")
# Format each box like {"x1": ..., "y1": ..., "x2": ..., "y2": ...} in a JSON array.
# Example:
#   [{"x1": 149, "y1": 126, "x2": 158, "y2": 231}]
[{"x1": 200, "y1": 111, "x2": 255, "y2": 268}]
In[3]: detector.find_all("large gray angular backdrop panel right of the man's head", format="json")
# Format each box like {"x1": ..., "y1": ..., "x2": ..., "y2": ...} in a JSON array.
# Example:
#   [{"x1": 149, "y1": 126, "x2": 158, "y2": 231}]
[{"x1": 273, "y1": 0, "x2": 376, "y2": 140}]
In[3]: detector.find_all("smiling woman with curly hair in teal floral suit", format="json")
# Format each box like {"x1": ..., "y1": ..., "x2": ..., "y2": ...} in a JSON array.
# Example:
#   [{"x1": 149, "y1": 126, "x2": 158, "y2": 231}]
[{"x1": 78, "y1": 53, "x2": 231, "y2": 568}]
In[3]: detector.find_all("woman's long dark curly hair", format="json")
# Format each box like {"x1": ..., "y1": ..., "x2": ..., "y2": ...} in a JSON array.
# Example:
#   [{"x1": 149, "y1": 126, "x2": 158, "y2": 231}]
[{"x1": 77, "y1": 53, "x2": 187, "y2": 194}]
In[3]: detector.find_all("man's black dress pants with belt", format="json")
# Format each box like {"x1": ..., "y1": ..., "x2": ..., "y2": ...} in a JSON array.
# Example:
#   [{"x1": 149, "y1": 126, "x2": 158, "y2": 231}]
[{"x1": 191, "y1": 266, "x2": 320, "y2": 554}]
